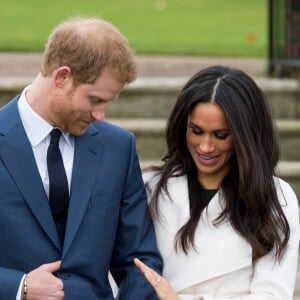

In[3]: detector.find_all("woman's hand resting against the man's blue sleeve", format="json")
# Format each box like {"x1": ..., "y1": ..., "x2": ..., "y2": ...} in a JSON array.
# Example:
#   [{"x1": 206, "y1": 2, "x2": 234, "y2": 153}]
[{"x1": 134, "y1": 258, "x2": 180, "y2": 300}]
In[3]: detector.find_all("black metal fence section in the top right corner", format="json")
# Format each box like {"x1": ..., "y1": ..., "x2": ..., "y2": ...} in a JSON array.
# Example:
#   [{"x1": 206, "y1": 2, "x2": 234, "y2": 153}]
[{"x1": 268, "y1": 0, "x2": 300, "y2": 77}]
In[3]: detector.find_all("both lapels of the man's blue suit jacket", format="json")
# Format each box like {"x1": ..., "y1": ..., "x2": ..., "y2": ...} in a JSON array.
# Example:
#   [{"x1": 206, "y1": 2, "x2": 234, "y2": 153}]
[{"x1": 0, "y1": 97, "x2": 103, "y2": 256}]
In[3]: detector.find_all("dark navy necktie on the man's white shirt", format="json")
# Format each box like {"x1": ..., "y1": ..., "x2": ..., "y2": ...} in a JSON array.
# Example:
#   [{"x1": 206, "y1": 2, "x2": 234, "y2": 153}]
[{"x1": 47, "y1": 128, "x2": 69, "y2": 245}]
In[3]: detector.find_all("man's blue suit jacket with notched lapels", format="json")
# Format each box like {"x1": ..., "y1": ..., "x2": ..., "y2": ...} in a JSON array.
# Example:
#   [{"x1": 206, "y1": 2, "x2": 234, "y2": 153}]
[{"x1": 0, "y1": 97, "x2": 162, "y2": 300}]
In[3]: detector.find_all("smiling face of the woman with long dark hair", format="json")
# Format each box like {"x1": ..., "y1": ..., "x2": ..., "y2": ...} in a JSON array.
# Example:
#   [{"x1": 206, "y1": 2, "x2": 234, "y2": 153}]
[{"x1": 186, "y1": 103, "x2": 234, "y2": 189}]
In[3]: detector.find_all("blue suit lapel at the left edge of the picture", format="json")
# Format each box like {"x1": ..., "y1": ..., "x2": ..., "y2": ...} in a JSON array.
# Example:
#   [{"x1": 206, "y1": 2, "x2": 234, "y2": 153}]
[{"x1": 0, "y1": 111, "x2": 61, "y2": 249}]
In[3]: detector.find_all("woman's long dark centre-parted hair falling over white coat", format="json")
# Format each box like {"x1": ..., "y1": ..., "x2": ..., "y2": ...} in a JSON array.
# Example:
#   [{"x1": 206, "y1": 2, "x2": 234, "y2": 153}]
[{"x1": 146, "y1": 66, "x2": 290, "y2": 260}]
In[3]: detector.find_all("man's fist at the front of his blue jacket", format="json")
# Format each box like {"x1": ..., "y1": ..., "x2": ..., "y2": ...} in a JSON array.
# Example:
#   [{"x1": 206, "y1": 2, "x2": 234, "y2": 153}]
[{"x1": 26, "y1": 261, "x2": 65, "y2": 300}]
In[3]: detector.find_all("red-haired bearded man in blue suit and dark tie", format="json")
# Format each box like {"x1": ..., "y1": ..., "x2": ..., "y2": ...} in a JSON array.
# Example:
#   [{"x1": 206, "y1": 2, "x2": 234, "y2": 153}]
[{"x1": 0, "y1": 18, "x2": 162, "y2": 300}]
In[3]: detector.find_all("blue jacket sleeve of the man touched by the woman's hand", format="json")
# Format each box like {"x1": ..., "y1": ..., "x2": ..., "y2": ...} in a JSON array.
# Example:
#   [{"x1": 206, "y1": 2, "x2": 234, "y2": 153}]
[{"x1": 111, "y1": 136, "x2": 162, "y2": 300}]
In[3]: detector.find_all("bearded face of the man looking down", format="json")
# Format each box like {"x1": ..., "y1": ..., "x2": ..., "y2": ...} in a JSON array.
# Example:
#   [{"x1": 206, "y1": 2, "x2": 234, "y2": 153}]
[{"x1": 49, "y1": 71, "x2": 124, "y2": 136}]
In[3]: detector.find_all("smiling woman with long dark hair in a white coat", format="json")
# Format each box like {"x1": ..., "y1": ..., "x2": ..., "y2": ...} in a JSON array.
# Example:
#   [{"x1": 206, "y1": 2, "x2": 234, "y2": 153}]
[{"x1": 135, "y1": 66, "x2": 299, "y2": 300}]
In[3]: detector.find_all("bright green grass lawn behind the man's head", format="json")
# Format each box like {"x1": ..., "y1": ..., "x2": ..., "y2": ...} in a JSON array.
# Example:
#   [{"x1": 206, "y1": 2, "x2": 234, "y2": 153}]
[{"x1": 0, "y1": 0, "x2": 268, "y2": 57}]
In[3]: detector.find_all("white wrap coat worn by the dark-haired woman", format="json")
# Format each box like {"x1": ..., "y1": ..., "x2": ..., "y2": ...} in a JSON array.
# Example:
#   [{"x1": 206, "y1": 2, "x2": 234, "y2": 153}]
[{"x1": 144, "y1": 172, "x2": 299, "y2": 300}]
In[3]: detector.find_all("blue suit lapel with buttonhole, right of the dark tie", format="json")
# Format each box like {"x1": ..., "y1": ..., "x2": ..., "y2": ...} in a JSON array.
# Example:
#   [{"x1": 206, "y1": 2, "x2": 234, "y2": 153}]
[{"x1": 63, "y1": 125, "x2": 103, "y2": 257}]
